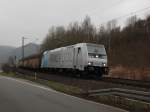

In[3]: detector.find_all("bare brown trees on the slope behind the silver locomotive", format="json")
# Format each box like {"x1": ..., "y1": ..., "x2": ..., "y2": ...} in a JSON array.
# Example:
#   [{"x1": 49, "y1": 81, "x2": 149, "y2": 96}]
[{"x1": 41, "y1": 16, "x2": 150, "y2": 67}]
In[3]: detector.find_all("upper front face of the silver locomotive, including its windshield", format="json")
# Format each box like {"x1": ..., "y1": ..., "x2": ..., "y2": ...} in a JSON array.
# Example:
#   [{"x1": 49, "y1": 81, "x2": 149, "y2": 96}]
[{"x1": 87, "y1": 44, "x2": 107, "y2": 59}]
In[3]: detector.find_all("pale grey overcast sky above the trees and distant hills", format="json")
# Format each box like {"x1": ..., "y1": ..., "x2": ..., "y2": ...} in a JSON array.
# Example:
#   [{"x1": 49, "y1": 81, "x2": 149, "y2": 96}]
[{"x1": 0, "y1": 0, "x2": 150, "y2": 46}]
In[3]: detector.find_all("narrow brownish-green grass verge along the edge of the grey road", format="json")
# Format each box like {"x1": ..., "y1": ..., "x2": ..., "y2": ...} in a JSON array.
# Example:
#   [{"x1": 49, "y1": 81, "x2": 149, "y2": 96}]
[{"x1": 0, "y1": 73, "x2": 150, "y2": 112}]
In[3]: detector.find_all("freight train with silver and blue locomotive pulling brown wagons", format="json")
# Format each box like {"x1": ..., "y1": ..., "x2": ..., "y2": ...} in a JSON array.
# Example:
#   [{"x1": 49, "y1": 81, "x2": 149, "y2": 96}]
[{"x1": 19, "y1": 43, "x2": 108, "y2": 77}]
